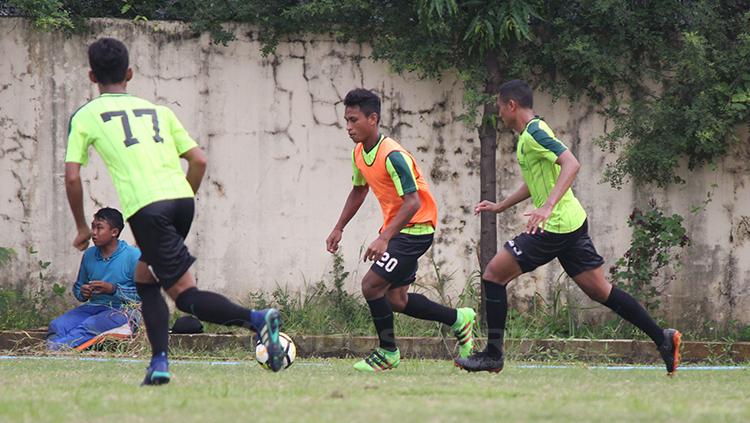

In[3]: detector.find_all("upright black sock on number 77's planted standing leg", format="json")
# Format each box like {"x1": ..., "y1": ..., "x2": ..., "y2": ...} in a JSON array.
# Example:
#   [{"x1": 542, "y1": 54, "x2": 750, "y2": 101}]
[{"x1": 135, "y1": 282, "x2": 169, "y2": 356}]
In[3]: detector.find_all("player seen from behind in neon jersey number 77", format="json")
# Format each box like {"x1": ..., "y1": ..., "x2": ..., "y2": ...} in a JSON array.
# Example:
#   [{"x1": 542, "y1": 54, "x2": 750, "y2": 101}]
[{"x1": 65, "y1": 38, "x2": 283, "y2": 385}]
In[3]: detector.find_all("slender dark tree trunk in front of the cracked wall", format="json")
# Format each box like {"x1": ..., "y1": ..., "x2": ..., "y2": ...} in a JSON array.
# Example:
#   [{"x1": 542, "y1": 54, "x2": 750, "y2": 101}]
[{"x1": 479, "y1": 50, "x2": 502, "y2": 328}]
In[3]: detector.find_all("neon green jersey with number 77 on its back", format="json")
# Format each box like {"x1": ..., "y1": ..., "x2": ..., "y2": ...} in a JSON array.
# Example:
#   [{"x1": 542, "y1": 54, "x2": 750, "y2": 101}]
[{"x1": 65, "y1": 94, "x2": 198, "y2": 219}]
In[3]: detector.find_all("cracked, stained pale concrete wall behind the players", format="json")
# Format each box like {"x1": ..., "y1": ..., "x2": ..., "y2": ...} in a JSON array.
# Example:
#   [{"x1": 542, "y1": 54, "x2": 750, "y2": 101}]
[{"x1": 0, "y1": 18, "x2": 750, "y2": 327}]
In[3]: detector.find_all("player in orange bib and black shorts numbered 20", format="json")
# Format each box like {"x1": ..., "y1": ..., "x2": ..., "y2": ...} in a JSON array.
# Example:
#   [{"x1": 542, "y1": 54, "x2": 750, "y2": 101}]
[{"x1": 326, "y1": 89, "x2": 475, "y2": 372}]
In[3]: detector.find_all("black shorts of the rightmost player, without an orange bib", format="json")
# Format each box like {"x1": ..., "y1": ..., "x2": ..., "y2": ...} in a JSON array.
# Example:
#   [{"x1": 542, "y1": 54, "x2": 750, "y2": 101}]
[{"x1": 504, "y1": 221, "x2": 604, "y2": 278}]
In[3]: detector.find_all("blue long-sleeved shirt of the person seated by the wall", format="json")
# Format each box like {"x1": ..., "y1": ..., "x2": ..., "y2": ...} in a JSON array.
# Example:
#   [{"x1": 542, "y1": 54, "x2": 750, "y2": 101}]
[{"x1": 73, "y1": 240, "x2": 141, "y2": 308}]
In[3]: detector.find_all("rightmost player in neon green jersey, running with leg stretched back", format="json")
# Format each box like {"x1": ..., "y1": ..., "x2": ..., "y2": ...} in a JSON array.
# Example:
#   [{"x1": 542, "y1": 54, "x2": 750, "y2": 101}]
[{"x1": 456, "y1": 80, "x2": 681, "y2": 375}]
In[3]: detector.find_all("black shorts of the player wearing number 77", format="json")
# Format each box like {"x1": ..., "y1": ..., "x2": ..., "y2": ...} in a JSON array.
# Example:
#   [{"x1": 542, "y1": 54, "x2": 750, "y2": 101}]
[{"x1": 128, "y1": 198, "x2": 195, "y2": 289}]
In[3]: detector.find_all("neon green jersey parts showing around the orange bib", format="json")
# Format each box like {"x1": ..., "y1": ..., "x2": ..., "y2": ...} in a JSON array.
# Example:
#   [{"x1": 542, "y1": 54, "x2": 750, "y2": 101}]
[{"x1": 352, "y1": 134, "x2": 435, "y2": 235}]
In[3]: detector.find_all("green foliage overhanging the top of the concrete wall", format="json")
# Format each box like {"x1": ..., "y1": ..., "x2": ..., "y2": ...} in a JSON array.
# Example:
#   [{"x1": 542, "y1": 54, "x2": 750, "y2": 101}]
[{"x1": 5, "y1": 0, "x2": 750, "y2": 187}]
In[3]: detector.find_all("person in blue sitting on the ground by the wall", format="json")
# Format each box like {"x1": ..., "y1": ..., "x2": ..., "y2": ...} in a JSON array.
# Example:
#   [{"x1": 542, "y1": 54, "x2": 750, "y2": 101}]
[{"x1": 47, "y1": 207, "x2": 141, "y2": 349}]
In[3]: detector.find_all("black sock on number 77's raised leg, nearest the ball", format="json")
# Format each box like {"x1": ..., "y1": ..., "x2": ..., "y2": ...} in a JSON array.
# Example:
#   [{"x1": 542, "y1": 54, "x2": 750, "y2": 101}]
[{"x1": 175, "y1": 288, "x2": 255, "y2": 330}]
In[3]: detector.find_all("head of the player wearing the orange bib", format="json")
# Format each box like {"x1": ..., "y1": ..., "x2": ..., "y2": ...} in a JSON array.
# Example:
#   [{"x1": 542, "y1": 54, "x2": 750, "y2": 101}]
[{"x1": 344, "y1": 88, "x2": 380, "y2": 142}]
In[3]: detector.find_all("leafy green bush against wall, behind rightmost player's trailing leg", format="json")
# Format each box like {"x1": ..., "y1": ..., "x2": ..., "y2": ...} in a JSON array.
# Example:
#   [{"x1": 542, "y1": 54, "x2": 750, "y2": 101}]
[{"x1": 609, "y1": 202, "x2": 690, "y2": 311}]
